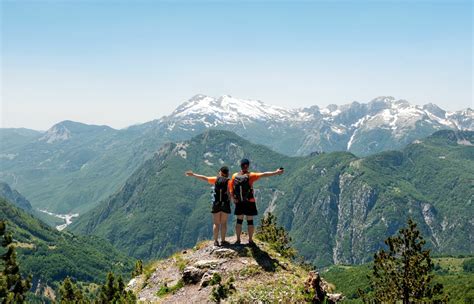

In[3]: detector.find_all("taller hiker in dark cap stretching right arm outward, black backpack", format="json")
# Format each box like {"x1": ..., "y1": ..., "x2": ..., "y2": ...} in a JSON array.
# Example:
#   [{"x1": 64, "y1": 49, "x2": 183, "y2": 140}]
[{"x1": 230, "y1": 159, "x2": 284, "y2": 245}]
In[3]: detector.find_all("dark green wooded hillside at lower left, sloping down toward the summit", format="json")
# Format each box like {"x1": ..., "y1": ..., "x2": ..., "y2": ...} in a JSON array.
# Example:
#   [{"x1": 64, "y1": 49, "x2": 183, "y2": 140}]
[{"x1": 0, "y1": 198, "x2": 134, "y2": 292}]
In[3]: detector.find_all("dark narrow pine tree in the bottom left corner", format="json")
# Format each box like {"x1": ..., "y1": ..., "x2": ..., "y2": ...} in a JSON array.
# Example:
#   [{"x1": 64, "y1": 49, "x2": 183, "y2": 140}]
[{"x1": 0, "y1": 221, "x2": 31, "y2": 303}]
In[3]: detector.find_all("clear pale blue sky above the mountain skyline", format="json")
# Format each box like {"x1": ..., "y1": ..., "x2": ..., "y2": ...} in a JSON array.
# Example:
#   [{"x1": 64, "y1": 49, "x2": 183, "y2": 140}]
[{"x1": 1, "y1": 0, "x2": 473, "y2": 130}]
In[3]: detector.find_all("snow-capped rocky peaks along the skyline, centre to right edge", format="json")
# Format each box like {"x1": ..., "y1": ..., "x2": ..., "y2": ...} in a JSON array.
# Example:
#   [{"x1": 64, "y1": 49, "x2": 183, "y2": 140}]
[{"x1": 142, "y1": 95, "x2": 474, "y2": 155}]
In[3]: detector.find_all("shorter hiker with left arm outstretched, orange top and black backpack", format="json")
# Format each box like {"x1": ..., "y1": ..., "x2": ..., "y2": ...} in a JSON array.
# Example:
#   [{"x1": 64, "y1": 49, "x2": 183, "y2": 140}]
[{"x1": 185, "y1": 166, "x2": 231, "y2": 246}]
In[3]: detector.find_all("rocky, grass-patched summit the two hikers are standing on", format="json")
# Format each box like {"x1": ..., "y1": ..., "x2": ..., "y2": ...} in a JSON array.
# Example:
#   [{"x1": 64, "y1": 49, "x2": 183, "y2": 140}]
[{"x1": 128, "y1": 235, "x2": 344, "y2": 303}]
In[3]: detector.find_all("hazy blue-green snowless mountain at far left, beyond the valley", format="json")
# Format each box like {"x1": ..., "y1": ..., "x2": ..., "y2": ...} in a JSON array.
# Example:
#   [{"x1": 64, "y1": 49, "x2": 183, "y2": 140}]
[{"x1": 0, "y1": 121, "x2": 156, "y2": 214}]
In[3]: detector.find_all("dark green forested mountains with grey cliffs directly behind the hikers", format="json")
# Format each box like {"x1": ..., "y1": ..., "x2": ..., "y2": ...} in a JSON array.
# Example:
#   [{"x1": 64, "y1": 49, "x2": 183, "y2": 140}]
[{"x1": 71, "y1": 130, "x2": 474, "y2": 266}]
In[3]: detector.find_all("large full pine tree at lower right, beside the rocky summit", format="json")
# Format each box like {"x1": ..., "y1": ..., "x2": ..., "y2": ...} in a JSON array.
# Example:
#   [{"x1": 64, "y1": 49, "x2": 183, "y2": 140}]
[{"x1": 359, "y1": 219, "x2": 447, "y2": 304}]
